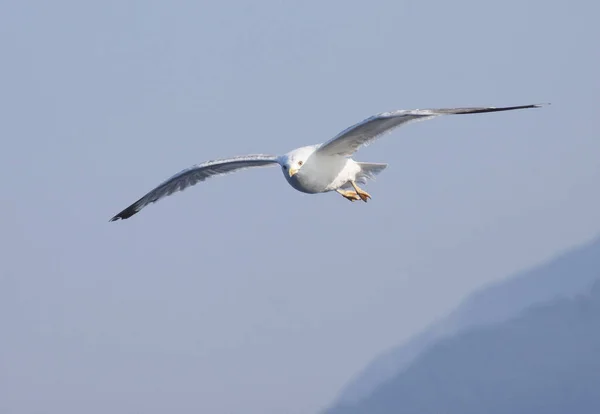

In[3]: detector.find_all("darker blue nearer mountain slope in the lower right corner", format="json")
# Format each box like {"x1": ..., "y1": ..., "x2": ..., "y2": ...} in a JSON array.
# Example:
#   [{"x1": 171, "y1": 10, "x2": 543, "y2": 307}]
[{"x1": 330, "y1": 281, "x2": 600, "y2": 414}]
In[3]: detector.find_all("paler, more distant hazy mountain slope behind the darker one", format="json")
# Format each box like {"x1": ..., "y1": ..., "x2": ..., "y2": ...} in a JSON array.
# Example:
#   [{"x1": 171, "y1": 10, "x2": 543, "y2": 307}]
[{"x1": 327, "y1": 238, "x2": 600, "y2": 414}]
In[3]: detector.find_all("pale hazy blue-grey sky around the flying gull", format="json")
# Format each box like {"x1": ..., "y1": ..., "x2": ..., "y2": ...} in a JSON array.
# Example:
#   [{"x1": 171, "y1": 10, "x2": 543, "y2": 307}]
[{"x1": 0, "y1": 0, "x2": 600, "y2": 414}]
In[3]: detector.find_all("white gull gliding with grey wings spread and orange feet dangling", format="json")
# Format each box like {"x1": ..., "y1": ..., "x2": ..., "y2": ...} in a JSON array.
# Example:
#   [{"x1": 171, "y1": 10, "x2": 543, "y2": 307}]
[{"x1": 109, "y1": 104, "x2": 546, "y2": 221}]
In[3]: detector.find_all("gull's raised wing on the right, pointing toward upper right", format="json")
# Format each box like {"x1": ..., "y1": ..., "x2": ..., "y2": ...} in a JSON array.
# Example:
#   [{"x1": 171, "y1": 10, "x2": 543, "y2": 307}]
[{"x1": 318, "y1": 105, "x2": 542, "y2": 156}]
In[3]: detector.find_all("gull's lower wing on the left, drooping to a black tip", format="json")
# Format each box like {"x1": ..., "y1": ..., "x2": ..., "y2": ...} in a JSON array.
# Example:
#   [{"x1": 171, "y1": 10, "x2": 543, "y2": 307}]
[{"x1": 110, "y1": 154, "x2": 277, "y2": 221}]
